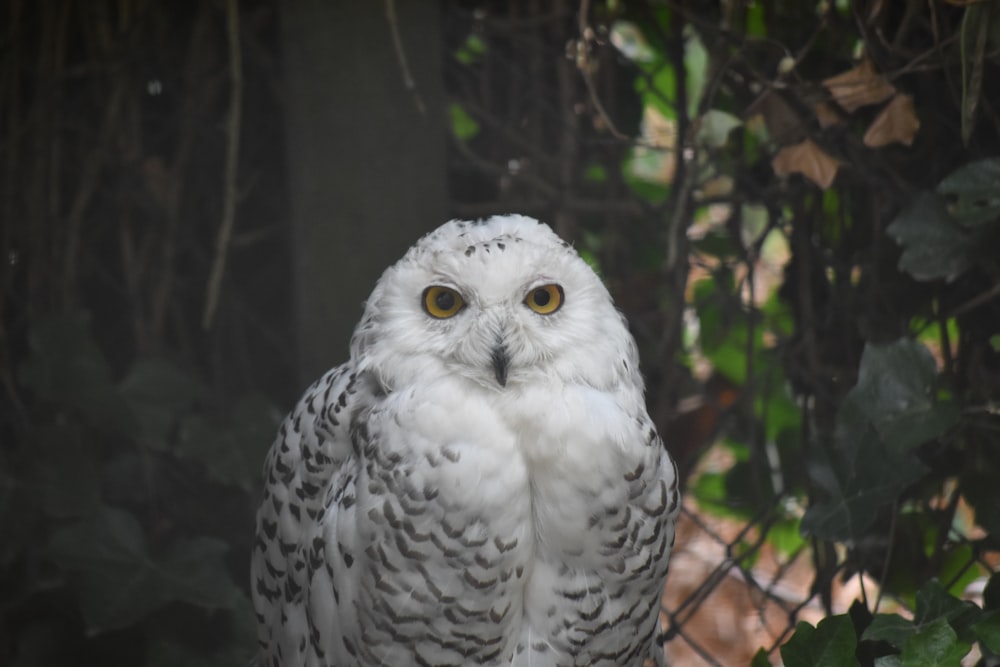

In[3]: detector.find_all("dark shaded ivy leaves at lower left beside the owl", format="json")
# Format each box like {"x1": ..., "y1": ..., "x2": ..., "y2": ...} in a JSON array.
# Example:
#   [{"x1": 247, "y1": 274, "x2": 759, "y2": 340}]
[{"x1": 0, "y1": 314, "x2": 279, "y2": 665}]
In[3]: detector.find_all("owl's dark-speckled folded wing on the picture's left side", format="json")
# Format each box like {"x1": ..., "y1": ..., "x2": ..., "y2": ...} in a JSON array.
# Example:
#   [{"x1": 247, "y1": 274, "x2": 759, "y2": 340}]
[{"x1": 250, "y1": 363, "x2": 371, "y2": 665}]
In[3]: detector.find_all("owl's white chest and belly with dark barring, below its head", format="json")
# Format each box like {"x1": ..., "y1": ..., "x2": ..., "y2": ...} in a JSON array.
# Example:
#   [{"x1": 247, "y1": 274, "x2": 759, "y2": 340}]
[{"x1": 338, "y1": 384, "x2": 672, "y2": 664}]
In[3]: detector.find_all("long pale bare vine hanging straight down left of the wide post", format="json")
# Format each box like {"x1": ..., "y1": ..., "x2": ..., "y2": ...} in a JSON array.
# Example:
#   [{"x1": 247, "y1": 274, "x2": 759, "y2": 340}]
[{"x1": 201, "y1": 0, "x2": 243, "y2": 329}]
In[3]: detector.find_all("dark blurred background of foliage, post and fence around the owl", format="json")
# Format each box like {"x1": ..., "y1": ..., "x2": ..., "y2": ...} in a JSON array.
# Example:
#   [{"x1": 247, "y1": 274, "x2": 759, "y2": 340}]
[{"x1": 0, "y1": 0, "x2": 1000, "y2": 667}]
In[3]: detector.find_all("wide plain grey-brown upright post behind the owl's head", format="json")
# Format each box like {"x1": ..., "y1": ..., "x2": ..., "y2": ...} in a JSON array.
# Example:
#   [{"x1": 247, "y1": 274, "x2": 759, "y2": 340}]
[{"x1": 281, "y1": 0, "x2": 448, "y2": 383}]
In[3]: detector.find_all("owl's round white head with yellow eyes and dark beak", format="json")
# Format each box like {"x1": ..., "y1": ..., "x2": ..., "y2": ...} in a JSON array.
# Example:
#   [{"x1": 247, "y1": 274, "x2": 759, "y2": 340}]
[{"x1": 351, "y1": 215, "x2": 641, "y2": 391}]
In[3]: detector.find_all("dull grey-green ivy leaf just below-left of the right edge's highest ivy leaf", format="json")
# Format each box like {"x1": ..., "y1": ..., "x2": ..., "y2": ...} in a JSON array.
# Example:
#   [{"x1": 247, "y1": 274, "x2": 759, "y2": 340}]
[{"x1": 886, "y1": 192, "x2": 975, "y2": 281}]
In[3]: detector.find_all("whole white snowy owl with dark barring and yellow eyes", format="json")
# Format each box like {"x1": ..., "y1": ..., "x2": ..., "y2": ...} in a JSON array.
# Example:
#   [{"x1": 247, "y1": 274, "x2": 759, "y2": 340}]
[{"x1": 251, "y1": 215, "x2": 679, "y2": 667}]
